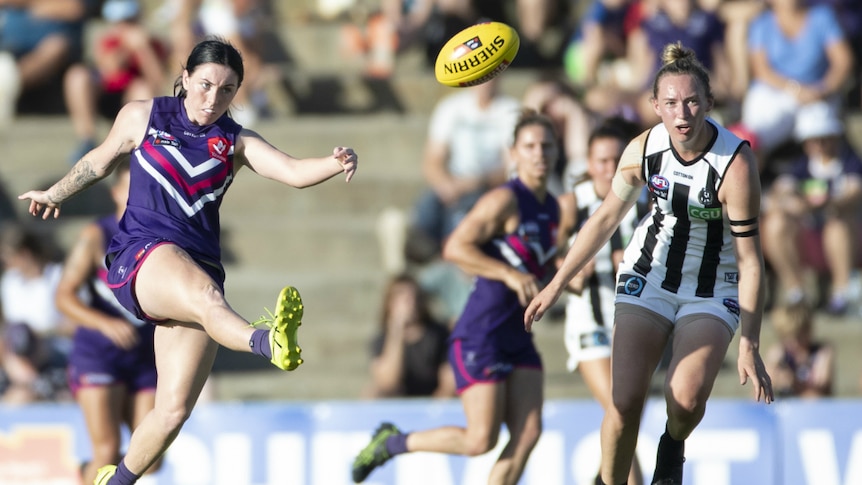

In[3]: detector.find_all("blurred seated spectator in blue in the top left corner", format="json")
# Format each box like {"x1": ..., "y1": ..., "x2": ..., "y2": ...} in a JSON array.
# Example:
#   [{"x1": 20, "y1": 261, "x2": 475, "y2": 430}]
[{"x1": 0, "y1": 0, "x2": 87, "y2": 127}]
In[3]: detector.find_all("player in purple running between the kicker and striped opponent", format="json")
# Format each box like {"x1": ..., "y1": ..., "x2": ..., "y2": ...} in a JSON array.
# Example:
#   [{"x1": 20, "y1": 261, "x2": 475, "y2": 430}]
[{"x1": 353, "y1": 112, "x2": 559, "y2": 485}]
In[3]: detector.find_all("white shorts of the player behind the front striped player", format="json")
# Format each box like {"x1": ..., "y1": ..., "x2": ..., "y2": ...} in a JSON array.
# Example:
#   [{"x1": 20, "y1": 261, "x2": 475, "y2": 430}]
[{"x1": 564, "y1": 287, "x2": 614, "y2": 372}]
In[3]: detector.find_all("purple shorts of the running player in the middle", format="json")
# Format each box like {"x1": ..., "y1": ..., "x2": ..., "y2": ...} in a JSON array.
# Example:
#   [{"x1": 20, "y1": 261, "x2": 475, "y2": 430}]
[{"x1": 449, "y1": 339, "x2": 542, "y2": 394}]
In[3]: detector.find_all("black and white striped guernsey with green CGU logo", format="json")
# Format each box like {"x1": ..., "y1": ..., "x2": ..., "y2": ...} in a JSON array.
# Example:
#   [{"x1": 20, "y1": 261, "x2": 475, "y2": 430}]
[{"x1": 620, "y1": 119, "x2": 747, "y2": 298}]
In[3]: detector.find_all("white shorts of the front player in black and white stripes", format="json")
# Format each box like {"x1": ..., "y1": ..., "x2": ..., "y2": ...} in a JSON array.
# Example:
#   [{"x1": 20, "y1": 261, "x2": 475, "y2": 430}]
[{"x1": 616, "y1": 274, "x2": 739, "y2": 336}]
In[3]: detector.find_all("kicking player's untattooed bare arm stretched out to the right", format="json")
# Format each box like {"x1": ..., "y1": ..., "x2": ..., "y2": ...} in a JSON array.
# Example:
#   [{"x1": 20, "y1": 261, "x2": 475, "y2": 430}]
[{"x1": 236, "y1": 129, "x2": 359, "y2": 188}]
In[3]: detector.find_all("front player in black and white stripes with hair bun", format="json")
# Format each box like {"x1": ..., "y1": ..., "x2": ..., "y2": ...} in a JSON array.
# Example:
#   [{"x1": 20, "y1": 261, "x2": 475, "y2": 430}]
[{"x1": 524, "y1": 43, "x2": 773, "y2": 485}]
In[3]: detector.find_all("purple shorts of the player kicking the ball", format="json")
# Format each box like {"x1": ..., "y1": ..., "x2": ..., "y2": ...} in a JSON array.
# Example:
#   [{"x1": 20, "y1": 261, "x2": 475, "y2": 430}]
[{"x1": 106, "y1": 239, "x2": 224, "y2": 323}]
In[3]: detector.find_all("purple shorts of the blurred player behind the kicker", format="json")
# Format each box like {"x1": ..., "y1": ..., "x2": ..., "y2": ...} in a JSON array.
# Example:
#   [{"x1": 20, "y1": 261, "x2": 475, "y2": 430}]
[{"x1": 67, "y1": 325, "x2": 157, "y2": 395}]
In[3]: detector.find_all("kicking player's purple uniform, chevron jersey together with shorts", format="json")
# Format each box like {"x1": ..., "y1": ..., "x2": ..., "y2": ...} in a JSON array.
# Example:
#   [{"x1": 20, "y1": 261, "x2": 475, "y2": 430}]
[{"x1": 107, "y1": 97, "x2": 242, "y2": 319}]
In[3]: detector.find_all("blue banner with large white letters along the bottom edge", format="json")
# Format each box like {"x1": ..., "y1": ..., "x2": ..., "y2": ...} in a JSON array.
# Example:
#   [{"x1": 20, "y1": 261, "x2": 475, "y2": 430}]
[{"x1": 0, "y1": 399, "x2": 862, "y2": 485}]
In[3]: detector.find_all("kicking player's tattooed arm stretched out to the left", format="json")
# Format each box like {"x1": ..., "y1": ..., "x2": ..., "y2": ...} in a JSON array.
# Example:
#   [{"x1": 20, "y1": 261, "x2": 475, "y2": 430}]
[{"x1": 18, "y1": 100, "x2": 152, "y2": 219}]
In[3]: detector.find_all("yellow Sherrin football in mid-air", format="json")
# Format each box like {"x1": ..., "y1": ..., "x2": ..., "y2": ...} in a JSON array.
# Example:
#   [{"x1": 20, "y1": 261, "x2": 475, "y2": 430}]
[{"x1": 434, "y1": 22, "x2": 521, "y2": 87}]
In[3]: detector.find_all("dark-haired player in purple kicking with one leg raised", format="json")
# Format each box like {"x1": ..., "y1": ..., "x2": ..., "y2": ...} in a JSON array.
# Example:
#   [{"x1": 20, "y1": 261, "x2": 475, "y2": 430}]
[{"x1": 19, "y1": 39, "x2": 358, "y2": 485}]
